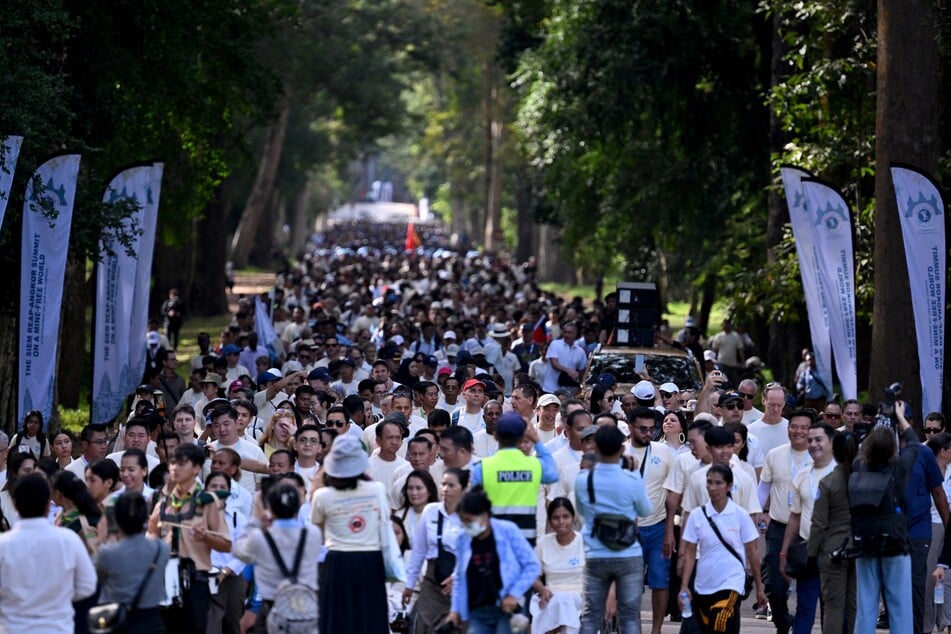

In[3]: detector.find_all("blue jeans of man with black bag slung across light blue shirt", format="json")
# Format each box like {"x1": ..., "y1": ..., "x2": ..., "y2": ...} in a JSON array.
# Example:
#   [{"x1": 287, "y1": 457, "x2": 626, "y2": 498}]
[{"x1": 580, "y1": 557, "x2": 644, "y2": 634}]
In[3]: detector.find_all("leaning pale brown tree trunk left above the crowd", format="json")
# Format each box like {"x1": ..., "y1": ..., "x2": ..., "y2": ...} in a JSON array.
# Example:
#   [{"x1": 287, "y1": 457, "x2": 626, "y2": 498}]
[{"x1": 231, "y1": 101, "x2": 290, "y2": 269}]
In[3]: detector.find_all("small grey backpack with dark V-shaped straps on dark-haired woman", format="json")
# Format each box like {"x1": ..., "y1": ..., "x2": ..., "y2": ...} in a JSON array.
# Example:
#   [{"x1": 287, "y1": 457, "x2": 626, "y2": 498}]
[{"x1": 263, "y1": 528, "x2": 317, "y2": 634}]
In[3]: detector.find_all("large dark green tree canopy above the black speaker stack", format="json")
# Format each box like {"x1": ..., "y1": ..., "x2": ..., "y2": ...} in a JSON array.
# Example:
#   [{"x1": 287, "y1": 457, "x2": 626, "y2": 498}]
[{"x1": 514, "y1": 0, "x2": 767, "y2": 286}]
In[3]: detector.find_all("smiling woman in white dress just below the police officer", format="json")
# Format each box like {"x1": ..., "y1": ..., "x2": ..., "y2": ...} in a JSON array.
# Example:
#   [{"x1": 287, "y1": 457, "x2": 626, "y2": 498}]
[{"x1": 530, "y1": 497, "x2": 584, "y2": 634}]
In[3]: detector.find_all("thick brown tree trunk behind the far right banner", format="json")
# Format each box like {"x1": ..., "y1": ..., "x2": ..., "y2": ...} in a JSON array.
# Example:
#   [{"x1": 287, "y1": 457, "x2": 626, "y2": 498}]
[{"x1": 869, "y1": 0, "x2": 941, "y2": 408}]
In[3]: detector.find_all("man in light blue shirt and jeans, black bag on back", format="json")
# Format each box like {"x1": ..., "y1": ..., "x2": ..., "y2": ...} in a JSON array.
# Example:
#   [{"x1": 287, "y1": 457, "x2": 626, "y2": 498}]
[{"x1": 575, "y1": 425, "x2": 651, "y2": 634}]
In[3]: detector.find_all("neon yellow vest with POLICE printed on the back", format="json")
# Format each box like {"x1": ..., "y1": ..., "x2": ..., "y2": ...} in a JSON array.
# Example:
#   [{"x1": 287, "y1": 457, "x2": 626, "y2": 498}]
[{"x1": 482, "y1": 449, "x2": 542, "y2": 540}]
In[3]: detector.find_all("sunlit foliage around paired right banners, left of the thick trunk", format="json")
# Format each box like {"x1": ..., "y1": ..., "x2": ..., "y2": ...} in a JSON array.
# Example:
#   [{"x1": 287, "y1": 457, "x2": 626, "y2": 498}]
[{"x1": 723, "y1": 0, "x2": 876, "y2": 324}]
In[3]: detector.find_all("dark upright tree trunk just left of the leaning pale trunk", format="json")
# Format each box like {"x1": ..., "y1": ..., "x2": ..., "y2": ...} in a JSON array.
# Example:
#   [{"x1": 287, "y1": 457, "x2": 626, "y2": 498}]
[{"x1": 187, "y1": 185, "x2": 228, "y2": 317}]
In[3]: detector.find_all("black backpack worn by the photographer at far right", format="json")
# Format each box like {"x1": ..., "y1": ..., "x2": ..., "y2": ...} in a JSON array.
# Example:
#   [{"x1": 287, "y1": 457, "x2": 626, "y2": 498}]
[{"x1": 849, "y1": 459, "x2": 909, "y2": 557}]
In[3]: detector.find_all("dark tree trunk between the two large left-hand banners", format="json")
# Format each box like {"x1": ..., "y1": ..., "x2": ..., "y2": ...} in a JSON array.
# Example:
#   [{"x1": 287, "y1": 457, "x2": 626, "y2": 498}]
[{"x1": 56, "y1": 249, "x2": 91, "y2": 409}]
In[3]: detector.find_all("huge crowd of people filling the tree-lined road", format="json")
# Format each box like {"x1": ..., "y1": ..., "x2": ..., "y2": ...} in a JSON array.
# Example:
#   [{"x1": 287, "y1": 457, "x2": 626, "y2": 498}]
[{"x1": 0, "y1": 218, "x2": 951, "y2": 634}]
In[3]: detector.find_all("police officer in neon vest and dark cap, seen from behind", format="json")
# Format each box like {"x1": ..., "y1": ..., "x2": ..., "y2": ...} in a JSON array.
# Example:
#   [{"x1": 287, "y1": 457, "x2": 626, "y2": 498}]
[{"x1": 472, "y1": 412, "x2": 558, "y2": 546}]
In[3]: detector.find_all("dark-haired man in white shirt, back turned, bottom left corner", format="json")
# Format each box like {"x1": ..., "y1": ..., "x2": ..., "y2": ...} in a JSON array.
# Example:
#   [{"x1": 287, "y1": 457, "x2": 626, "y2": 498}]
[{"x1": 0, "y1": 473, "x2": 96, "y2": 634}]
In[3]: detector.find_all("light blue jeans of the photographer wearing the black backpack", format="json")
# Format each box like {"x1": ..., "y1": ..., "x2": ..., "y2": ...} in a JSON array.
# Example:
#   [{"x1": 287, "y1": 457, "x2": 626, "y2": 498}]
[{"x1": 854, "y1": 555, "x2": 913, "y2": 634}]
